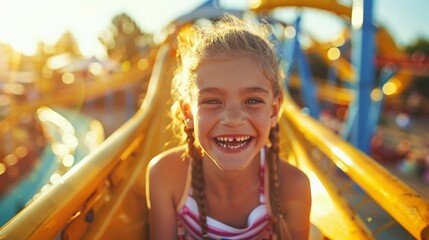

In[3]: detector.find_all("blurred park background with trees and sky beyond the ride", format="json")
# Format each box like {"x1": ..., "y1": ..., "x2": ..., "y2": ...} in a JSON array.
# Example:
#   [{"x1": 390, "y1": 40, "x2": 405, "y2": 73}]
[{"x1": 0, "y1": 0, "x2": 429, "y2": 238}]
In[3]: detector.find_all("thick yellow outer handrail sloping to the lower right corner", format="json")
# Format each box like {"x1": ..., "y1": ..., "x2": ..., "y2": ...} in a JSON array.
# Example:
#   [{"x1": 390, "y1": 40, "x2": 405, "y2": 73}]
[{"x1": 284, "y1": 92, "x2": 429, "y2": 240}]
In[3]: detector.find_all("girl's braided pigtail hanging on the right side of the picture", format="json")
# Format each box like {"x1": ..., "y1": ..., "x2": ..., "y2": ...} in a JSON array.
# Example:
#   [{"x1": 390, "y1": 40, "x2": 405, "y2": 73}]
[{"x1": 268, "y1": 124, "x2": 292, "y2": 240}]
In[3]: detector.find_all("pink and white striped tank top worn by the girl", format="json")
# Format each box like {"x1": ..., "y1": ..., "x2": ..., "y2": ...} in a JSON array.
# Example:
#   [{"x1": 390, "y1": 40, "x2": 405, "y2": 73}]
[{"x1": 177, "y1": 148, "x2": 275, "y2": 240}]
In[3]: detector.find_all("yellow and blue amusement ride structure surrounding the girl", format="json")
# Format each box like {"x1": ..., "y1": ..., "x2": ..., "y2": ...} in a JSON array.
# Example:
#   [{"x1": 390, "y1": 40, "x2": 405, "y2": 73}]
[{"x1": 0, "y1": 0, "x2": 429, "y2": 240}]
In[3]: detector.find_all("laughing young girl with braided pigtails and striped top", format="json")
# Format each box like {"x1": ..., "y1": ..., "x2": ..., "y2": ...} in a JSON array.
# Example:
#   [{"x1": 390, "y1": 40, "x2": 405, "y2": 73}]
[{"x1": 146, "y1": 16, "x2": 311, "y2": 240}]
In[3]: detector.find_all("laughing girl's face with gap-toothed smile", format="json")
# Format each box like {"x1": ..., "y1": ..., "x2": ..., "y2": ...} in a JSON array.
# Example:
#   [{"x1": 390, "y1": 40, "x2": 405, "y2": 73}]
[{"x1": 185, "y1": 57, "x2": 281, "y2": 171}]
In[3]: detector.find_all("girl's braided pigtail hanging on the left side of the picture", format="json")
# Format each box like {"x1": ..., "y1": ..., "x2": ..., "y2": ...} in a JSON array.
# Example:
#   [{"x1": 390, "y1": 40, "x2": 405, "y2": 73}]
[{"x1": 185, "y1": 126, "x2": 208, "y2": 239}]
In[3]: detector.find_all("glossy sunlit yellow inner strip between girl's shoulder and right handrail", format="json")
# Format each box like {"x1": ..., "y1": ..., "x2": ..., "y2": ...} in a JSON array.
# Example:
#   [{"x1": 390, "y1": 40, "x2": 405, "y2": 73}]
[{"x1": 280, "y1": 114, "x2": 375, "y2": 240}]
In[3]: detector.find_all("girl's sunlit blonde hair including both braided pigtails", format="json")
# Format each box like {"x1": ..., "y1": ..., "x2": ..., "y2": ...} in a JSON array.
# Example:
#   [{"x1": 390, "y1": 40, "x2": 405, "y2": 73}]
[{"x1": 172, "y1": 15, "x2": 283, "y2": 237}]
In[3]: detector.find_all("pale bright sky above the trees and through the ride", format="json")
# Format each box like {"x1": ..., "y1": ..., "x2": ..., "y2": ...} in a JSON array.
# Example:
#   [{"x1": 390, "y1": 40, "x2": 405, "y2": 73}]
[{"x1": 0, "y1": 0, "x2": 429, "y2": 58}]
